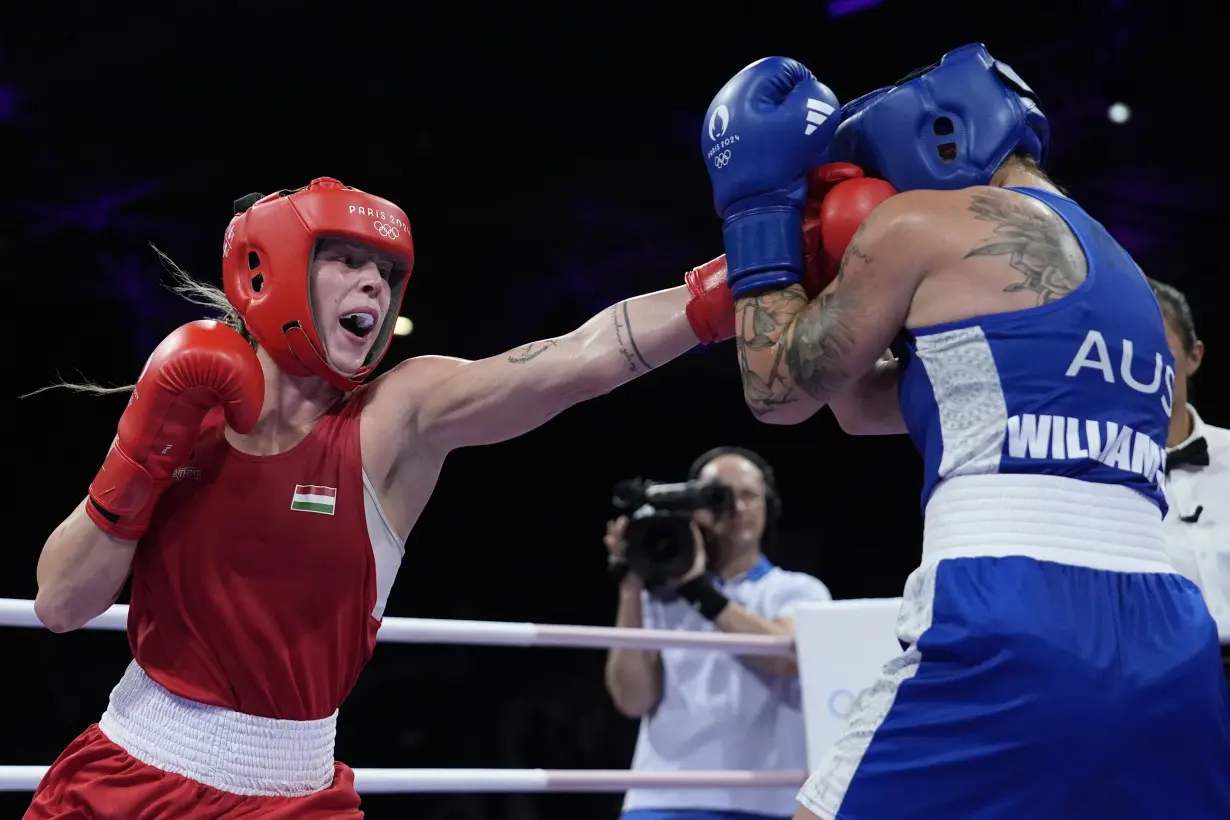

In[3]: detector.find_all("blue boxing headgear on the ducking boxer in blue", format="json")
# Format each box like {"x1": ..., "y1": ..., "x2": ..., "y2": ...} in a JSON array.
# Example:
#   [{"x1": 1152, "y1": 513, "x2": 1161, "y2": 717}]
[{"x1": 830, "y1": 43, "x2": 1050, "y2": 191}]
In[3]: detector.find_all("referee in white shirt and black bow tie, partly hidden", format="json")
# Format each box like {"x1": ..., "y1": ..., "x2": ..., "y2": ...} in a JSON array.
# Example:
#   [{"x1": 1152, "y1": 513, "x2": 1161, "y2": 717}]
[{"x1": 1151, "y1": 282, "x2": 1230, "y2": 686}]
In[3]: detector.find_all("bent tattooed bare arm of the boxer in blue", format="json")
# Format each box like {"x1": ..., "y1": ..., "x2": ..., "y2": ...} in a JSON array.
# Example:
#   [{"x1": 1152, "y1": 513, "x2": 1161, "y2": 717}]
[{"x1": 736, "y1": 194, "x2": 924, "y2": 424}]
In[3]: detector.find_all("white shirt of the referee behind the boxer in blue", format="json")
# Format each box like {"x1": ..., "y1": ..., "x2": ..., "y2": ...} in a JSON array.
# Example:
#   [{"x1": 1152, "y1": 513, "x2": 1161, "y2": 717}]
[{"x1": 1162, "y1": 404, "x2": 1230, "y2": 644}]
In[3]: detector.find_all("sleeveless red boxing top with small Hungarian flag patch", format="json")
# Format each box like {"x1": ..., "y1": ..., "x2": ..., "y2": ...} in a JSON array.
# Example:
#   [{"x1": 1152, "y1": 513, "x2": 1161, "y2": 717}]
[{"x1": 128, "y1": 387, "x2": 379, "y2": 720}]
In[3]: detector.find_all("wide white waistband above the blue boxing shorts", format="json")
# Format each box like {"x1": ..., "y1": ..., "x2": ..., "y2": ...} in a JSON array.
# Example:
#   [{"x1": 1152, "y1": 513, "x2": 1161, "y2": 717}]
[{"x1": 923, "y1": 473, "x2": 1175, "y2": 573}]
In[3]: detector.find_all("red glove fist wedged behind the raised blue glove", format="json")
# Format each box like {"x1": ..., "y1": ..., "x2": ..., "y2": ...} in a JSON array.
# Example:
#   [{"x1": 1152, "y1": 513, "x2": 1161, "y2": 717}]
[{"x1": 803, "y1": 162, "x2": 897, "y2": 299}]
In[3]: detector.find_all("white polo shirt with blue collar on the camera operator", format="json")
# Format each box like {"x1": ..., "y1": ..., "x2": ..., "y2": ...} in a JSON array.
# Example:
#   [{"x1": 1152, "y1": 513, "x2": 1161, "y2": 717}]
[{"x1": 624, "y1": 558, "x2": 833, "y2": 818}]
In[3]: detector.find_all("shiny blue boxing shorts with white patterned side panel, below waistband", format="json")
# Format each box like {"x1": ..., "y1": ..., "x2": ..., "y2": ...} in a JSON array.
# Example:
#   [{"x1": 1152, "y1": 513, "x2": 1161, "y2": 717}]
[{"x1": 798, "y1": 557, "x2": 1230, "y2": 820}]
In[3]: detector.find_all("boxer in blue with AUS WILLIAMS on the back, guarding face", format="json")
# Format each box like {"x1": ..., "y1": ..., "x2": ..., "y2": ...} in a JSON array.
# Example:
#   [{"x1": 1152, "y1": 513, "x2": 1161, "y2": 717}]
[{"x1": 701, "y1": 44, "x2": 1230, "y2": 820}]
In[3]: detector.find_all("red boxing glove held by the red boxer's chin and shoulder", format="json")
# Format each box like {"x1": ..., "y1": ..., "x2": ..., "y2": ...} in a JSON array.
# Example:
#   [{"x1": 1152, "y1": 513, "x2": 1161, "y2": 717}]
[{"x1": 85, "y1": 321, "x2": 264, "y2": 541}]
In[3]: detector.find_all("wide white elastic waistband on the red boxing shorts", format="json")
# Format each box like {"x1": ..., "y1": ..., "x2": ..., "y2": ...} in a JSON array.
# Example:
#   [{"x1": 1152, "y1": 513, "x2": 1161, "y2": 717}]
[{"x1": 98, "y1": 660, "x2": 337, "y2": 797}]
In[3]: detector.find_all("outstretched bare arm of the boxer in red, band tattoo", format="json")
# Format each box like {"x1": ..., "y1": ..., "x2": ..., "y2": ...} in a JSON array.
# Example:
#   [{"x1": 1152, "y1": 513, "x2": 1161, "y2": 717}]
[{"x1": 396, "y1": 286, "x2": 697, "y2": 454}]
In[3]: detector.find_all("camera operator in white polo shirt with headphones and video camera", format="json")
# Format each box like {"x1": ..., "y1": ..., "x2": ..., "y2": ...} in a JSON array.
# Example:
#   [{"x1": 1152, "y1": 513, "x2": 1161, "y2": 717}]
[{"x1": 604, "y1": 447, "x2": 831, "y2": 820}]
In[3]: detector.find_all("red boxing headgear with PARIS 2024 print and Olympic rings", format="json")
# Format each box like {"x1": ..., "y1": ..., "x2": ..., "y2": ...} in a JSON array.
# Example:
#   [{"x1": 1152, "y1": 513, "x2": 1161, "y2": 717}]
[{"x1": 223, "y1": 177, "x2": 415, "y2": 390}]
